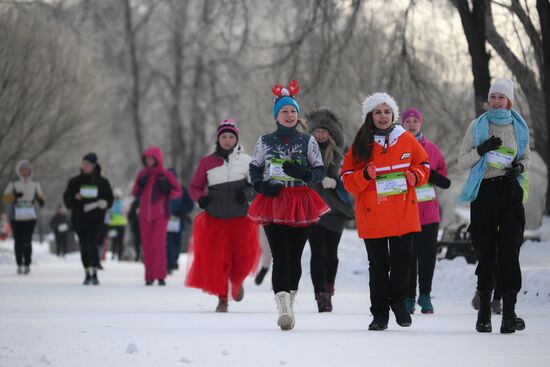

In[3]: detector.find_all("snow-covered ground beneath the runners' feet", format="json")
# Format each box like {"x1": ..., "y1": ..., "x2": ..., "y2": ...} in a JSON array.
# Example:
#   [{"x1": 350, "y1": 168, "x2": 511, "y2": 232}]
[{"x1": 0, "y1": 231, "x2": 550, "y2": 367}]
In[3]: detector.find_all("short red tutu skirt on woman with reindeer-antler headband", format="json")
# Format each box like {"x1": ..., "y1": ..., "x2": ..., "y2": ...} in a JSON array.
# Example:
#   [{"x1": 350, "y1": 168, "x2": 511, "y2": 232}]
[{"x1": 248, "y1": 186, "x2": 330, "y2": 227}]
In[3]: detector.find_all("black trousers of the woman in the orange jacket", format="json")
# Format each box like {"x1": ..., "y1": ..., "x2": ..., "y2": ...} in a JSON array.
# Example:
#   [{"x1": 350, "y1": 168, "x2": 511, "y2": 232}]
[{"x1": 365, "y1": 233, "x2": 414, "y2": 315}]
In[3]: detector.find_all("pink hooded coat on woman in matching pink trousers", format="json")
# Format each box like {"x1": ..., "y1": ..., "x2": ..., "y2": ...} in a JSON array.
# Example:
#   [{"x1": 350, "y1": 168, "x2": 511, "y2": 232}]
[{"x1": 132, "y1": 147, "x2": 182, "y2": 222}]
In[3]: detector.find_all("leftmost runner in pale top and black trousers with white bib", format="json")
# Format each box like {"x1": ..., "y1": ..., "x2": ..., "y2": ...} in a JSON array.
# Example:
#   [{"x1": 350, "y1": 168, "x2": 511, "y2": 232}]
[{"x1": 3, "y1": 160, "x2": 44, "y2": 274}]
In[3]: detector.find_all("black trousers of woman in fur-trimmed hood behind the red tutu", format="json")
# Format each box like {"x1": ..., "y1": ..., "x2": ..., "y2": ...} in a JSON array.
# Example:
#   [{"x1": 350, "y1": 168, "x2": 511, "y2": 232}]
[{"x1": 308, "y1": 225, "x2": 342, "y2": 293}]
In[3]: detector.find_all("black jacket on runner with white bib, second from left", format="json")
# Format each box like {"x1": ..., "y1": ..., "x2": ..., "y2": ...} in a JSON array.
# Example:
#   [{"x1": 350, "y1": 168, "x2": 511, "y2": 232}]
[{"x1": 63, "y1": 165, "x2": 113, "y2": 232}]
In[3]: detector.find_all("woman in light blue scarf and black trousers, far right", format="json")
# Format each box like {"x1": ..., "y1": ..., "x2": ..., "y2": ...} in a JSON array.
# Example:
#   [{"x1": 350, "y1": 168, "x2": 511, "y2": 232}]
[{"x1": 458, "y1": 79, "x2": 531, "y2": 334}]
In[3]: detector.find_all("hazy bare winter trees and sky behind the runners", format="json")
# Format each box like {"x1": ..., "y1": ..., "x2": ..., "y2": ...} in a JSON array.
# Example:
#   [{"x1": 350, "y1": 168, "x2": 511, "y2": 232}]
[{"x1": 0, "y1": 0, "x2": 550, "y2": 229}]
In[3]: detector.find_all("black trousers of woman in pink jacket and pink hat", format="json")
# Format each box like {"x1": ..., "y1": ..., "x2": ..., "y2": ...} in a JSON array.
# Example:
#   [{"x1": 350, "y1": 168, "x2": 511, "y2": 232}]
[{"x1": 408, "y1": 223, "x2": 439, "y2": 298}]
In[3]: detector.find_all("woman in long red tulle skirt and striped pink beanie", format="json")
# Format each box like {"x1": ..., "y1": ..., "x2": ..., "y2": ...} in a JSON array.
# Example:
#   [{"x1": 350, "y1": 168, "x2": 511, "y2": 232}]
[{"x1": 185, "y1": 119, "x2": 260, "y2": 312}]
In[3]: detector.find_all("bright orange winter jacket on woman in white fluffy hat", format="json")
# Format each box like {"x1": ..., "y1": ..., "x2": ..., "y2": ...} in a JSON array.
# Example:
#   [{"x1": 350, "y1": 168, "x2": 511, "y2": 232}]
[{"x1": 341, "y1": 125, "x2": 430, "y2": 238}]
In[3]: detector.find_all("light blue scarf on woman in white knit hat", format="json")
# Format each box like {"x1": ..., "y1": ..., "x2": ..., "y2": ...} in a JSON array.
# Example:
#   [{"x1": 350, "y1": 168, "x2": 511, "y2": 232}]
[{"x1": 458, "y1": 109, "x2": 529, "y2": 202}]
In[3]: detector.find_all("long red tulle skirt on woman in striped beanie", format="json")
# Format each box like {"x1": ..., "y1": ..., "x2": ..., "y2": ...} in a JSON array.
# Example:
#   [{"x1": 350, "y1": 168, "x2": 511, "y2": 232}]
[{"x1": 185, "y1": 212, "x2": 261, "y2": 299}]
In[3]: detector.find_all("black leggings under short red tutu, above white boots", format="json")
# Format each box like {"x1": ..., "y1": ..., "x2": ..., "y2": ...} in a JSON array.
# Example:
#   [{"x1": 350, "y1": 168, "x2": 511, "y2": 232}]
[{"x1": 264, "y1": 224, "x2": 309, "y2": 293}]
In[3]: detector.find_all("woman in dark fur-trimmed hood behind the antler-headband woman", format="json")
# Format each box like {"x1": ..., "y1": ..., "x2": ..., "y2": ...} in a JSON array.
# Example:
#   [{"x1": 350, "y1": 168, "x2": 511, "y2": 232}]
[{"x1": 307, "y1": 108, "x2": 355, "y2": 312}]
